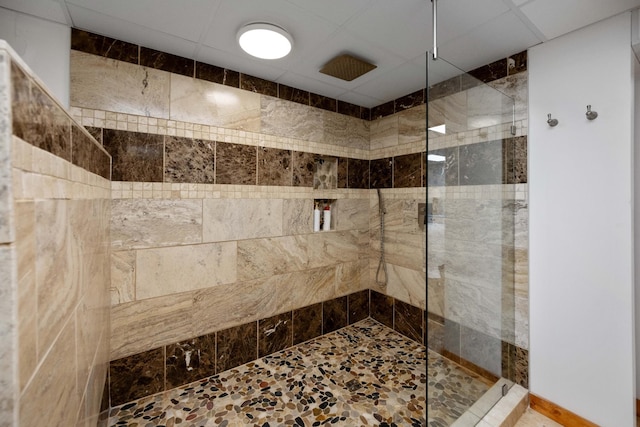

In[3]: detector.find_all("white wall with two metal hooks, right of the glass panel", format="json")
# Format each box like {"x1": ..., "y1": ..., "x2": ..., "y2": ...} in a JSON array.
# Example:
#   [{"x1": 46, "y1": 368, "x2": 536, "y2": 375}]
[{"x1": 528, "y1": 13, "x2": 635, "y2": 427}]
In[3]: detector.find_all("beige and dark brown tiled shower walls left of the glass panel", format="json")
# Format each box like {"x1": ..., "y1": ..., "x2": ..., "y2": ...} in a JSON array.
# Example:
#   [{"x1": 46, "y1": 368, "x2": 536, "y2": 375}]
[{"x1": 2, "y1": 30, "x2": 426, "y2": 425}]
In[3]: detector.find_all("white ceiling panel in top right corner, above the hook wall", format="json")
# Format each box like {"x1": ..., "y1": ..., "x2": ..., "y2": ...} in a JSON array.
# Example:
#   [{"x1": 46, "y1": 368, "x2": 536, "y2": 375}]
[{"x1": 520, "y1": 0, "x2": 640, "y2": 39}]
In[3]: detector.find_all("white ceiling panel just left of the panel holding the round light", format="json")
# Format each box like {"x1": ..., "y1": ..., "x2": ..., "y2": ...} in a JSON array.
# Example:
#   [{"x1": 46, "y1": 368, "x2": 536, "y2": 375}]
[{"x1": 66, "y1": 0, "x2": 219, "y2": 42}]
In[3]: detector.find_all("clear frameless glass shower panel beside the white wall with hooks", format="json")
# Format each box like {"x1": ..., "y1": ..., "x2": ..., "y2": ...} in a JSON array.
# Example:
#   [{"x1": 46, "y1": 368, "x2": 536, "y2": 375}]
[{"x1": 427, "y1": 54, "x2": 515, "y2": 425}]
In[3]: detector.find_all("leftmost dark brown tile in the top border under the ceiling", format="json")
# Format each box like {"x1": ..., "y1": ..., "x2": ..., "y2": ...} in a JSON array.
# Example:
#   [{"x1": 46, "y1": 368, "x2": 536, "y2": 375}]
[{"x1": 71, "y1": 28, "x2": 138, "y2": 64}]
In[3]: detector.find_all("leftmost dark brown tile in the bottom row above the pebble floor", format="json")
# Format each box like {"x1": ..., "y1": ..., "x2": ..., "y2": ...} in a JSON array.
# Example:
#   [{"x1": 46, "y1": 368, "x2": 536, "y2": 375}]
[{"x1": 109, "y1": 347, "x2": 164, "y2": 407}]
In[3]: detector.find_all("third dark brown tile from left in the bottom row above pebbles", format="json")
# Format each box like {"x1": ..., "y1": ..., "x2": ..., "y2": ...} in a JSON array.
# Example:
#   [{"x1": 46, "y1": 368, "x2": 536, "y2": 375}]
[{"x1": 216, "y1": 322, "x2": 258, "y2": 373}]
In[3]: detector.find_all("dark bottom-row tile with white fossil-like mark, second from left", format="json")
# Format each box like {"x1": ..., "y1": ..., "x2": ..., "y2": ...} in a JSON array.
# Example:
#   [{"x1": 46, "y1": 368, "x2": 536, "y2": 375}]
[{"x1": 165, "y1": 332, "x2": 216, "y2": 390}]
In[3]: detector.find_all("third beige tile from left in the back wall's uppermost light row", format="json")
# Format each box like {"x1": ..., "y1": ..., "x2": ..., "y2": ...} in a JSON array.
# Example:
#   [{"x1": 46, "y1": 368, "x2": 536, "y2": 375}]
[{"x1": 260, "y1": 96, "x2": 324, "y2": 142}]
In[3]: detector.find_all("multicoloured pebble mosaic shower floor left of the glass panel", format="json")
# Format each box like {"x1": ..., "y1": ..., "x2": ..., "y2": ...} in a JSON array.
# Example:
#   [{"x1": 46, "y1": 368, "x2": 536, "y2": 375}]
[{"x1": 108, "y1": 318, "x2": 424, "y2": 427}]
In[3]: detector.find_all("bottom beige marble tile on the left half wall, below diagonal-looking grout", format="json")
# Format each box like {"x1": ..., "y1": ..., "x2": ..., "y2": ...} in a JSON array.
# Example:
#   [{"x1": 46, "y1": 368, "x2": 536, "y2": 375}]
[{"x1": 19, "y1": 320, "x2": 80, "y2": 426}]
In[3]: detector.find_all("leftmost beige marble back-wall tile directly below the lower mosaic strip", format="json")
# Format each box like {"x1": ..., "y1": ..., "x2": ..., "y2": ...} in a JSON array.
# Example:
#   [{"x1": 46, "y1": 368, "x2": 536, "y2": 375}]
[{"x1": 110, "y1": 199, "x2": 203, "y2": 250}]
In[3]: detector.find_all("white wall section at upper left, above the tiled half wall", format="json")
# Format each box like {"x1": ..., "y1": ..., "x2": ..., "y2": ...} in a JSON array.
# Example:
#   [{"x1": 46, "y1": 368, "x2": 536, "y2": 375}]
[{"x1": 0, "y1": 7, "x2": 71, "y2": 109}]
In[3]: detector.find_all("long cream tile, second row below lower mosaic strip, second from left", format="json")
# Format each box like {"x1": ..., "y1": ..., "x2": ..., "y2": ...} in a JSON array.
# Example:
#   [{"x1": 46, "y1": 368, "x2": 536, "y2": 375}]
[{"x1": 136, "y1": 242, "x2": 238, "y2": 300}]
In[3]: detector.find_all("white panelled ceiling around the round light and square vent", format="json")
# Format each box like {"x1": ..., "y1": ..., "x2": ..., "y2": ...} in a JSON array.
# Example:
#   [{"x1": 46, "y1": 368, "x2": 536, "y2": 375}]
[{"x1": 0, "y1": 0, "x2": 640, "y2": 107}]
